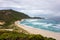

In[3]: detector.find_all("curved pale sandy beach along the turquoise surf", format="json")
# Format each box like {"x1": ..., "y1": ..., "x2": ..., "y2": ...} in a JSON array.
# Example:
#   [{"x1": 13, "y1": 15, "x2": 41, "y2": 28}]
[{"x1": 15, "y1": 21, "x2": 60, "y2": 40}]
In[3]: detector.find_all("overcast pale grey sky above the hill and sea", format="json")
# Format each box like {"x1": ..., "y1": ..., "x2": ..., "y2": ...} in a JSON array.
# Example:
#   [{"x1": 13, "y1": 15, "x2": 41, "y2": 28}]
[{"x1": 0, "y1": 0, "x2": 60, "y2": 18}]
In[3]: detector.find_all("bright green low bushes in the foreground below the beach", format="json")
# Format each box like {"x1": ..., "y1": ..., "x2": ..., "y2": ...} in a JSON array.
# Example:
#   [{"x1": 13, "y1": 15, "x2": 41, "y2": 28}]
[{"x1": 0, "y1": 31, "x2": 55, "y2": 40}]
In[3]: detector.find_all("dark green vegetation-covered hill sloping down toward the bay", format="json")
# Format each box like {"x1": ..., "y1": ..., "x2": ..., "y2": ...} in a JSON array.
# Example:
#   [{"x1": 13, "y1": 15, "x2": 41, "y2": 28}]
[{"x1": 0, "y1": 9, "x2": 29, "y2": 26}]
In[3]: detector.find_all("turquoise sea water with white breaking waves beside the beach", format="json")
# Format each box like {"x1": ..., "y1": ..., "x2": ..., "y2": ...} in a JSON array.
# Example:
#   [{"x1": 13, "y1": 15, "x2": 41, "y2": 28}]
[{"x1": 20, "y1": 19, "x2": 60, "y2": 32}]
